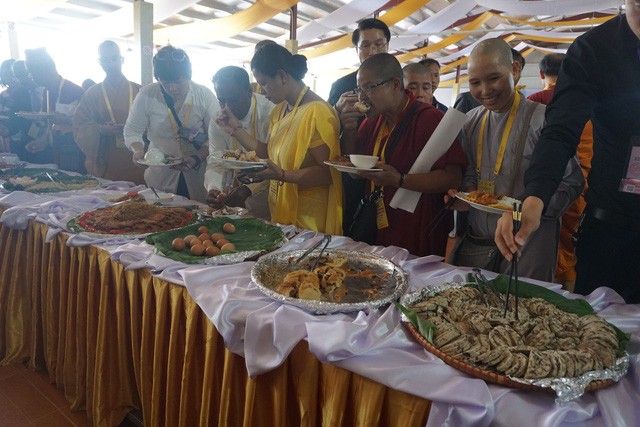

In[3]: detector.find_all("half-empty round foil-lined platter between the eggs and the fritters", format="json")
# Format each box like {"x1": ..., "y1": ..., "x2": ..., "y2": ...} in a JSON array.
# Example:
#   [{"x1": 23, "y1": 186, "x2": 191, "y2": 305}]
[{"x1": 251, "y1": 249, "x2": 408, "y2": 314}]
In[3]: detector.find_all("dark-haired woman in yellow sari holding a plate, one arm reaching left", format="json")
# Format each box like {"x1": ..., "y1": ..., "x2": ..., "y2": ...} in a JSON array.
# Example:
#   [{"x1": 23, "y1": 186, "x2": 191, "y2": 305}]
[{"x1": 216, "y1": 44, "x2": 342, "y2": 234}]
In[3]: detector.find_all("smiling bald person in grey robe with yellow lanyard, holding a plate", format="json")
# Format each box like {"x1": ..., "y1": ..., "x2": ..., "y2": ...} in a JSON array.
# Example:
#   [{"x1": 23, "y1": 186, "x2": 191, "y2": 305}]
[{"x1": 449, "y1": 39, "x2": 584, "y2": 281}]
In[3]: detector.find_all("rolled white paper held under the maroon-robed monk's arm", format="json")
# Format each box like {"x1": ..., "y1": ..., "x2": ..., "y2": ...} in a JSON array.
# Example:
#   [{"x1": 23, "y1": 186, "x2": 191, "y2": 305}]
[{"x1": 389, "y1": 108, "x2": 467, "y2": 213}]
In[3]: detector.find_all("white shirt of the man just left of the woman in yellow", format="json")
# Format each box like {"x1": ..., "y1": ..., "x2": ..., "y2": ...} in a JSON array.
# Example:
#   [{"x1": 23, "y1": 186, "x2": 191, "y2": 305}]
[{"x1": 204, "y1": 94, "x2": 275, "y2": 191}]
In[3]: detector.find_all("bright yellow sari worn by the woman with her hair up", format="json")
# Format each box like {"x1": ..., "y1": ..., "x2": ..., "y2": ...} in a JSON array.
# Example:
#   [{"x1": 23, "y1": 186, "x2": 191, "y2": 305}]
[{"x1": 267, "y1": 101, "x2": 342, "y2": 235}]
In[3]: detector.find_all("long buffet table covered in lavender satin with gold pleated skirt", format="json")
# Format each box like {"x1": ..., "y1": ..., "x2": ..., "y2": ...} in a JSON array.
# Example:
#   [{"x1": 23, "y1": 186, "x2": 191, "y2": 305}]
[{"x1": 0, "y1": 165, "x2": 640, "y2": 426}]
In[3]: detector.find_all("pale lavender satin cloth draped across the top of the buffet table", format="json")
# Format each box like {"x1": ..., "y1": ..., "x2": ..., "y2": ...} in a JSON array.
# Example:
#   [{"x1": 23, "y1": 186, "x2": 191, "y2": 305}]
[{"x1": 0, "y1": 182, "x2": 640, "y2": 426}]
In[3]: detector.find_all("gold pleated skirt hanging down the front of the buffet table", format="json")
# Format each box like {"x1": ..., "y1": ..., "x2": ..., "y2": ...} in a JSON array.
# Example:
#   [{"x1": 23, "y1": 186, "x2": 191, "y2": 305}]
[{"x1": 0, "y1": 222, "x2": 431, "y2": 426}]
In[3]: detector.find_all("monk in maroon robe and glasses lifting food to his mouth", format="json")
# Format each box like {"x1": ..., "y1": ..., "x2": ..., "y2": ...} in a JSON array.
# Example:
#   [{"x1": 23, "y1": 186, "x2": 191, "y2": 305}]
[{"x1": 341, "y1": 53, "x2": 466, "y2": 256}]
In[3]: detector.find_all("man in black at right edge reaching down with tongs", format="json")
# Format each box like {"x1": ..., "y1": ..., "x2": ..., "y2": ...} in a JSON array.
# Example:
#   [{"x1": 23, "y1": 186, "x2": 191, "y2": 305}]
[{"x1": 495, "y1": 0, "x2": 640, "y2": 303}]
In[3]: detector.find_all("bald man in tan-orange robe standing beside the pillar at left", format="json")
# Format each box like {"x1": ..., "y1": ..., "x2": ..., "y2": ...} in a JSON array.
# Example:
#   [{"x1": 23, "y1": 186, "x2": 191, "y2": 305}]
[{"x1": 73, "y1": 40, "x2": 144, "y2": 184}]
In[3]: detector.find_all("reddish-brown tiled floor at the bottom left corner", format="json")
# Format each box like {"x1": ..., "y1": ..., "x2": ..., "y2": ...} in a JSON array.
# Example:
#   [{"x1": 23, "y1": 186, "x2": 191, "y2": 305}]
[{"x1": 0, "y1": 365, "x2": 92, "y2": 427}]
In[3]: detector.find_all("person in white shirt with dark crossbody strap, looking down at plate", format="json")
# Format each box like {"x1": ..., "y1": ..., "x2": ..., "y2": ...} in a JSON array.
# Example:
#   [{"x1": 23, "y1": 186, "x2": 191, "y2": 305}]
[{"x1": 124, "y1": 46, "x2": 219, "y2": 202}]
